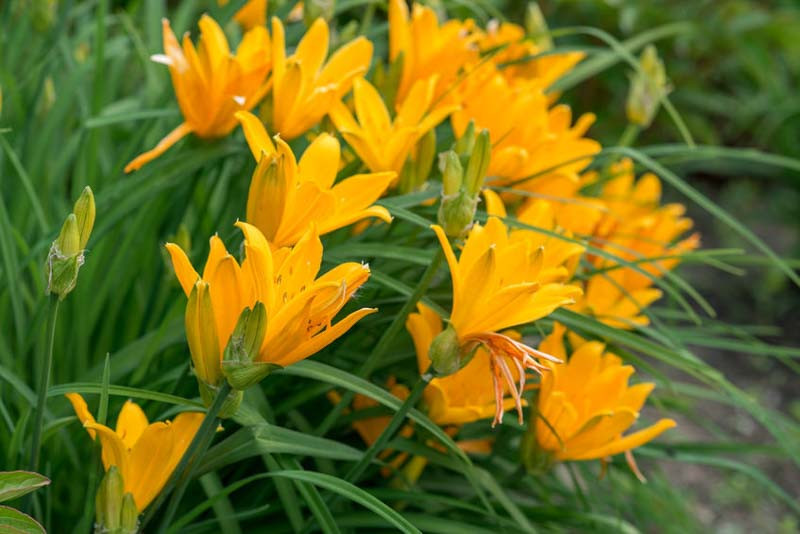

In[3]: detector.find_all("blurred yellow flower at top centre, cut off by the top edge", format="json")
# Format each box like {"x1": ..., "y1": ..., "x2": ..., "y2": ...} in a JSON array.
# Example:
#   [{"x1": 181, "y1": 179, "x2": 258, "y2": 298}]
[{"x1": 389, "y1": 0, "x2": 479, "y2": 107}]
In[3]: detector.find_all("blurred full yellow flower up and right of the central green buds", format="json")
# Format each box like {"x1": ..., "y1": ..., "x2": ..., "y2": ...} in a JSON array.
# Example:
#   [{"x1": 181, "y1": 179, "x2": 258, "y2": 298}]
[{"x1": 451, "y1": 63, "x2": 600, "y2": 190}]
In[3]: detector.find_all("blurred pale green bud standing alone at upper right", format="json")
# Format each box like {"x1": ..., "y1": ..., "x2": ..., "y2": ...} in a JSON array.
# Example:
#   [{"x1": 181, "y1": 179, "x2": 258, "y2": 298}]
[{"x1": 625, "y1": 45, "x2": 671, "y2": 128}]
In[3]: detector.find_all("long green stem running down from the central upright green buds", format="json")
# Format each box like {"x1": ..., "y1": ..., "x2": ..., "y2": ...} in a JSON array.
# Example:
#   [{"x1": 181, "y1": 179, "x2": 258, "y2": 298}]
[{"x1": 315, "y1": 249, "x2": 444, "y2": 436}]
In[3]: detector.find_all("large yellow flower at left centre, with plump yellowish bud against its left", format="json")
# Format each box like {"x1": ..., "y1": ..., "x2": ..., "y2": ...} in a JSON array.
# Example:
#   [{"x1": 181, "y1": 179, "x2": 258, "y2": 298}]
[{"x1": 166, "y1": 222, "x2": 377, "y2": 376}]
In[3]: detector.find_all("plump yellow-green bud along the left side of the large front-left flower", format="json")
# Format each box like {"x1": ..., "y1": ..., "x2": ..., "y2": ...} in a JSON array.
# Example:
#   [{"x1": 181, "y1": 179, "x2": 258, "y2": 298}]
[{"x1": 185, "y1": 280, "x2": 222, "y2": 390}]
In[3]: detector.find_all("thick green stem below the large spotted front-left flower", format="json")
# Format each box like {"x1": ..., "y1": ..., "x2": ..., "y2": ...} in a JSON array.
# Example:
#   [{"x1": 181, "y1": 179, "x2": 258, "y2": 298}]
[{"x1": 142, "y1": 382, "x2": 231, "y2": 532}]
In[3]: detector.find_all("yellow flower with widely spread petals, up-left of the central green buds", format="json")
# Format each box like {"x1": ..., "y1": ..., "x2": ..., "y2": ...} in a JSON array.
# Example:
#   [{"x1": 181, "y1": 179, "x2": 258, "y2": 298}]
[{"x1": 330, "y1": 76, "x2": 458, "y2": 178}]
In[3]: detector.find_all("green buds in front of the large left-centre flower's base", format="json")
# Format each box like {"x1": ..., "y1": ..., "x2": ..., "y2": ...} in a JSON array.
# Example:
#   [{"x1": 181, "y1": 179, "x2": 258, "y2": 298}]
[{"x1": 222, "y1": 302, "x2": 280, "y2": 391}]
